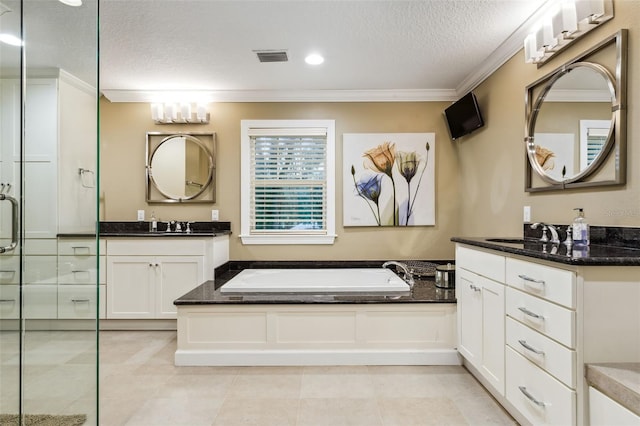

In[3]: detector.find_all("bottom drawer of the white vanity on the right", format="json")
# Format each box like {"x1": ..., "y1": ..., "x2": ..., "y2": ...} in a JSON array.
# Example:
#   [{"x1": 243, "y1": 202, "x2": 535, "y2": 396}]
[{"x1": 506, "y1": 346, "x2": 576, "y2": 425}]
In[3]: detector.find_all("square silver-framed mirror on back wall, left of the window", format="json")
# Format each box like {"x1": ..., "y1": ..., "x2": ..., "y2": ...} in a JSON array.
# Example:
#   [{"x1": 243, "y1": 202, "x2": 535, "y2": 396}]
[{"x1": 146, "y1": 132, "x2": 215, "y2": 203}]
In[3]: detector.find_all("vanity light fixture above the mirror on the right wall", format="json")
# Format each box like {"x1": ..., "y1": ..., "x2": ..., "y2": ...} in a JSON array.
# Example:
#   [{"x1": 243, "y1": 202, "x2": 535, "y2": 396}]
[{"x1": 524, "y1": 0, "x2": 613, "y2": 67}]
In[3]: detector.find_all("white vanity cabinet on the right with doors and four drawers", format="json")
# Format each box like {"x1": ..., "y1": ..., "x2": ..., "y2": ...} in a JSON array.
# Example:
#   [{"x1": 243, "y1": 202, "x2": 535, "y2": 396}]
[{"x1": 456, "y1": 243, "x2": 640, "y2": 425}]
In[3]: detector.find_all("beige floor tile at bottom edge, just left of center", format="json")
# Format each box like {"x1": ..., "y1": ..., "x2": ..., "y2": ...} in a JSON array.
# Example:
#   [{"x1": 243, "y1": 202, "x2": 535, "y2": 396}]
[{"x1": 213, "y1": 398, "x2": 298, "y2": 426}]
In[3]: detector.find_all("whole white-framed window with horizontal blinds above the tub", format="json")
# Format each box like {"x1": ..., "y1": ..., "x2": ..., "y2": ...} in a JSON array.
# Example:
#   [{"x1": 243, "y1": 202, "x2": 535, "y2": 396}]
[{"x1": 240, "y1": 120, "x2": 335, "y2": 244}]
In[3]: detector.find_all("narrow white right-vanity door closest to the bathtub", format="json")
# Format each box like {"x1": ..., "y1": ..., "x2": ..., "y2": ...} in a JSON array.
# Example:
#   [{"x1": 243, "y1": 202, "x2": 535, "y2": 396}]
[{"x1": 456, "y1": 269, "x2": 482, "y2": 368}]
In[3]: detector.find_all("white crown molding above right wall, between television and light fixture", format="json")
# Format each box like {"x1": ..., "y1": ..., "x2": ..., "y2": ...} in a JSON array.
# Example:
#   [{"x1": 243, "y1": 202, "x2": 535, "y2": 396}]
[{"x1": 456, "y1": 0, "x2": 556, "y2": 98}]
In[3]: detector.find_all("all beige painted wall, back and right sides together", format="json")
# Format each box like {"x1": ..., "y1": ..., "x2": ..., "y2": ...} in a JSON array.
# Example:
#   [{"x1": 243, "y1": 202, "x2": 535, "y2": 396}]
[{"x1": 100, "y1": 0, "x2": 640, "y2": 260}]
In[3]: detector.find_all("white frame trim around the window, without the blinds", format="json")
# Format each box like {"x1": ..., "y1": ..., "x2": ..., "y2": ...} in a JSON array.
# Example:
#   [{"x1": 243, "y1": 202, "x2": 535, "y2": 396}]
[{"x1": 240, "y1": 120, "x2": 336, "y2": 245}]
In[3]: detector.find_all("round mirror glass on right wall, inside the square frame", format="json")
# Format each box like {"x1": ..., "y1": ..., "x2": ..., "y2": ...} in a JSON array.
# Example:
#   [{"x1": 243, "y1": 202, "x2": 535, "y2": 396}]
[{"x1": 526, "y1": 62, "x2": 616, "y2": 183}]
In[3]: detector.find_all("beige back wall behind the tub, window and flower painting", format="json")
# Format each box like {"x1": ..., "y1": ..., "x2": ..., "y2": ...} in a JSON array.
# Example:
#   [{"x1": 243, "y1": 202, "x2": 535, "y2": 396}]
[{"x1": 100, "y1": 99, "x2": 460, "y2": 260}]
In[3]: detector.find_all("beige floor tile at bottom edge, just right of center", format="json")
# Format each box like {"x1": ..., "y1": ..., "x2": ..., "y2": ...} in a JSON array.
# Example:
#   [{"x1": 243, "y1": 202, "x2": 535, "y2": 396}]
[{"x1": 378, "y1": 398, "x2": 469, "y2": 426}]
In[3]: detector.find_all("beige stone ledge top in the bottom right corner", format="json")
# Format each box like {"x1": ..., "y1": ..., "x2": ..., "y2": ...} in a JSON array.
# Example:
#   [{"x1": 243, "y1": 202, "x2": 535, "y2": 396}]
[{"x1": 585, "y1": 362, "x2": 640, "y2": 416}]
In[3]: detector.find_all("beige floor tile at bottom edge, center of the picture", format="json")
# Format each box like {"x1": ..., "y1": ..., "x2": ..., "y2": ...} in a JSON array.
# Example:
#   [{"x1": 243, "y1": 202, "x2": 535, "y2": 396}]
[{"x1": 296, "y1": 398, "x2": 382, "y2": 426}]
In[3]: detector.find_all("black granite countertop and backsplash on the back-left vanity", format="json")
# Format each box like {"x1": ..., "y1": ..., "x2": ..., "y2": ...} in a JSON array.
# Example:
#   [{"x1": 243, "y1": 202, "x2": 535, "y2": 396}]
[{"x1": 100, "y1": 221, "x2": 231, "y2": 237}]
